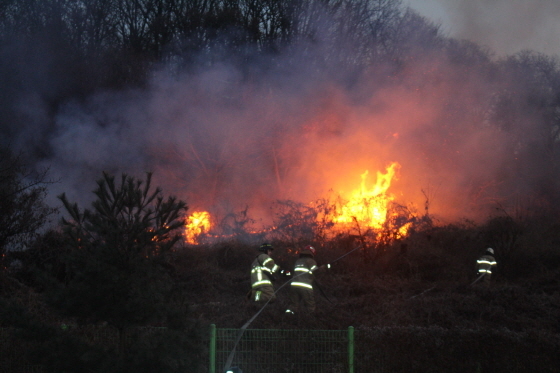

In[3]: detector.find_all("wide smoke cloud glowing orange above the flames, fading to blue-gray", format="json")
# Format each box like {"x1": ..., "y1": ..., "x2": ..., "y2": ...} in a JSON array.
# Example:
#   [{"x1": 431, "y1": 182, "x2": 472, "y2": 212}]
[{"x1": 2, "y1": 0, "x2": 560, "y2": 230}]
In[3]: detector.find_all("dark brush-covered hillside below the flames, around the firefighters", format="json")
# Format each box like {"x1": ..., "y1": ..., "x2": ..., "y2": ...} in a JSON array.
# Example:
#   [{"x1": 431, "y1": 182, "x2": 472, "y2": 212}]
[{"x1": 2, "y1": 212, "x2": 560, "y2": 372}]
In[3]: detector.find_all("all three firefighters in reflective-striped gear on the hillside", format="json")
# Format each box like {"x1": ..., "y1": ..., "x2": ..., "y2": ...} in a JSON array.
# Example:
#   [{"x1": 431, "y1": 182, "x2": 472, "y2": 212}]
[{"x1": 249, "y1": 243, "x2": 497, "y2": 315}]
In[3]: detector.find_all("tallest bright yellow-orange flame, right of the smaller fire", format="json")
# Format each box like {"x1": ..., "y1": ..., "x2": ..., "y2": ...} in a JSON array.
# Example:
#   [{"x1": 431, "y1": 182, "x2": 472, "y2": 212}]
[{"x1": 333, "y1": 162, "x2": 400, "y2": 229}]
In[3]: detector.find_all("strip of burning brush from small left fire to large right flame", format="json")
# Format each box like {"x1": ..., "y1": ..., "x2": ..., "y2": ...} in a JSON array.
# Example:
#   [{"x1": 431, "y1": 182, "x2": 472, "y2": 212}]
[{"x1": 185, "y1": 162, "x2": 419, "y2": 245}]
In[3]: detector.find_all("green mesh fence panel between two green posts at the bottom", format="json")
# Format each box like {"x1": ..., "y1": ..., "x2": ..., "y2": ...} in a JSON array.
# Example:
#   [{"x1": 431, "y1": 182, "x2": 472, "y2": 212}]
[{"x1": 209, "y1": 325, "x2": 354, "y2": 373}]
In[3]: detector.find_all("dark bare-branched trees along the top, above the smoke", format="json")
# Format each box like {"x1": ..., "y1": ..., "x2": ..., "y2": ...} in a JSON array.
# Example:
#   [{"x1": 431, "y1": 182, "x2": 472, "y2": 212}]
[{"x1": 0, "y1": 0, "x2": 440, "y2": 163}]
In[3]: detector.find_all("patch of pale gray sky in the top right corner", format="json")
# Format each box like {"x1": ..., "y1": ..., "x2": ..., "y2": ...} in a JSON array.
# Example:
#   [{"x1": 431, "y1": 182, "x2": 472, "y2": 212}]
[{"x1": 403, "y1": 0, "x2": 560, "y2": 57}]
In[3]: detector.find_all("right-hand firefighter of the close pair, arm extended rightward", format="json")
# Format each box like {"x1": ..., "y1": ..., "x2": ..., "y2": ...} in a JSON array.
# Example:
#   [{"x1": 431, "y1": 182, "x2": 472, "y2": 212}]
[{"x1": 286, "y1": 245, "x2": 331, "y2": 315}]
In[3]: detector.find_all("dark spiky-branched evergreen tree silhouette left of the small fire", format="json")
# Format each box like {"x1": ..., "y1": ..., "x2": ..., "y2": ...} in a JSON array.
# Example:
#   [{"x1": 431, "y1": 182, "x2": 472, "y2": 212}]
[{"x1": 50, "y1": 173, "x2": 187, "y2": 331}]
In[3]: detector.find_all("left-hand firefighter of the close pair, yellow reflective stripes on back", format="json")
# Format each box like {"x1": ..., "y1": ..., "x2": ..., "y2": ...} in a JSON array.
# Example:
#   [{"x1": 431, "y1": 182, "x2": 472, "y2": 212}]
[{"x1": 250, "y1": 243, "x2": 280, "y2": 303}]
